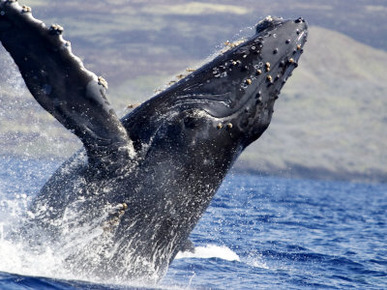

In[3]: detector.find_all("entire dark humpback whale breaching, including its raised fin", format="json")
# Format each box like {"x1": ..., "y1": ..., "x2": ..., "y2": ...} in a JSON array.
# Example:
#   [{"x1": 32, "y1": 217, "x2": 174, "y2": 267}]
[{"x1": 0, "y1": 0, "x2": 307, "y2": 281}]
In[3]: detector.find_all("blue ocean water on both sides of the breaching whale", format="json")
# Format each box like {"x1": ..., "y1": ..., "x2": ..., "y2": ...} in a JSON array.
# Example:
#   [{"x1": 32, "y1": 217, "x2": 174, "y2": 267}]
[{"x1": 0, "y1": 157, "x2": 387, "y2": 289}]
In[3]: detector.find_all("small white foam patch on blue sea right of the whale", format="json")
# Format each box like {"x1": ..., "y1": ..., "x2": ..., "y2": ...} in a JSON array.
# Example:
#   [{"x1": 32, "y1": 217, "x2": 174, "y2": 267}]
[{"x1": 176, "y1": 244, "x2": 240, "y2": 261}]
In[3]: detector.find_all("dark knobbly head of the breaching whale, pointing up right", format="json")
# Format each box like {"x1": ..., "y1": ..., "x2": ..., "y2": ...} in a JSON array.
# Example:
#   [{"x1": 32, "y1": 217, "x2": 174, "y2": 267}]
[{"x1": 124, "y1": 16, "x2": 307, "y2": 170}]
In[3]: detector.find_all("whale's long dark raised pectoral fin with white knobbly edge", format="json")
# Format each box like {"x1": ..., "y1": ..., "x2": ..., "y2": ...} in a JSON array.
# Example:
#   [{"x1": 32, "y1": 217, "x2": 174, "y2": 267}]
[{"x1": 0, "y1": 0, "x2": 132, "y2": 163}]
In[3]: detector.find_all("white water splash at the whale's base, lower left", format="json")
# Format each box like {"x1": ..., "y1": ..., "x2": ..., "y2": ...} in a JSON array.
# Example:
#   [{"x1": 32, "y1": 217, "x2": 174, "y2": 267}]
[{"x1": 0, "y1": 187, "x2": 155, "y2": 287}]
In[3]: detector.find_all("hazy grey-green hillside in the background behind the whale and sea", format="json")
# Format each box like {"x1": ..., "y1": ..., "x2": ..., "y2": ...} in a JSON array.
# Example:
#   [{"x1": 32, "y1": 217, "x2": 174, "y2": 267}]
[{"x1": 0, "y1": 0, "x2": 387, "y2": 182}]
